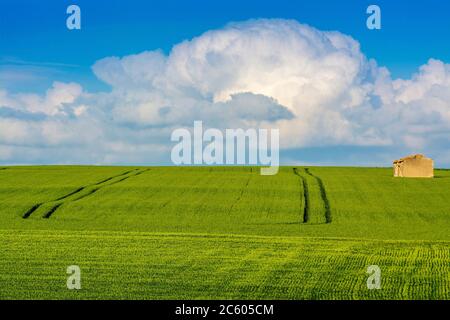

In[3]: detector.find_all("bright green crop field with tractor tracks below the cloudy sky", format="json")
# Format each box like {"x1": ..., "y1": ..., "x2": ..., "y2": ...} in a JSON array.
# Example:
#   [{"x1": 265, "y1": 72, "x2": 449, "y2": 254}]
[{"x1": 0, "y1": 166, "x2": 450, "y2": 299}]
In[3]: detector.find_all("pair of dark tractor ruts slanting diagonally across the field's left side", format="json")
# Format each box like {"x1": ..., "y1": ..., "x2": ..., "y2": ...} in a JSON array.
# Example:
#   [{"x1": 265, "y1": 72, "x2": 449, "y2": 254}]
[{"x1": 22, "y1": 169, "x2": 150, "y2": 219}]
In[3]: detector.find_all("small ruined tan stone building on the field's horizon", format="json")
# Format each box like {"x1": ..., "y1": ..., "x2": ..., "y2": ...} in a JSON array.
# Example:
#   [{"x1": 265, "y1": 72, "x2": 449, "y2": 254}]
[{"x1": 394, "y1": 154, "x2": 434, "y2": 178}]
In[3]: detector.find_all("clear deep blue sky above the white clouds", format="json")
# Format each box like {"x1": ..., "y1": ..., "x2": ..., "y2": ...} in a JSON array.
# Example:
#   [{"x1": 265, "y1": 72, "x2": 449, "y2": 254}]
[{"x1": 0, "y1": 0, "x2": 450, "y2": 91}]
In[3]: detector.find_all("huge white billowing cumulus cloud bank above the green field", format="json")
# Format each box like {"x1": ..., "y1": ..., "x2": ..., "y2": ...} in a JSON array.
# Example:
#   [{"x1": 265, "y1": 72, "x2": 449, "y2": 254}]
[{"x1": 0, "y1": 20, "x2": 450, "y2": 163}]
